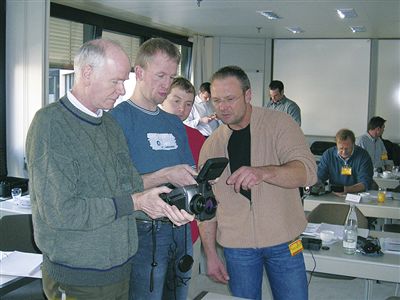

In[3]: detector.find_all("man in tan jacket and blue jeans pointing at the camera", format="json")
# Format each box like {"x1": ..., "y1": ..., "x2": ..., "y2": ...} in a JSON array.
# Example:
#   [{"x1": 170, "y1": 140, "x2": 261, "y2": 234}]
[{"x1": 199, "y1": 66, "x2": 317, "y2": 299}]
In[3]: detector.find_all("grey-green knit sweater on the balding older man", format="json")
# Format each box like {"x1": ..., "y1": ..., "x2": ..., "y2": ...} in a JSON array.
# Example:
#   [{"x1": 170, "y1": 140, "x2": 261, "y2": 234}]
[{"x1": 26, "y1": 97, "x2": 143, "y2": 286}]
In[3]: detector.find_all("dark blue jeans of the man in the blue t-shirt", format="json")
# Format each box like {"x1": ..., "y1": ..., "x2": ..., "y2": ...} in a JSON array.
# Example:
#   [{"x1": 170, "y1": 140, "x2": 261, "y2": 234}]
[{"x1": 129, "y1": 221, "x2": 193, "y2": 300}]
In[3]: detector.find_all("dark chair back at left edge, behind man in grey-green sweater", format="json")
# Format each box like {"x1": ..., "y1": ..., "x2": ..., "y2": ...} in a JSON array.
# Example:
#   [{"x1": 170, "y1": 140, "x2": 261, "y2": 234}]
[{"x1": 0, "y1": 214, "x2": 41, "y2": 253}]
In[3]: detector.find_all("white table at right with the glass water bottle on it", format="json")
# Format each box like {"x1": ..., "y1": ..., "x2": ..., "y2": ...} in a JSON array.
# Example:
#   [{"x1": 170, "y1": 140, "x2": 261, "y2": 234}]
[{"x1": 303, "y1": 231, "x2": 400, "y2": 299}]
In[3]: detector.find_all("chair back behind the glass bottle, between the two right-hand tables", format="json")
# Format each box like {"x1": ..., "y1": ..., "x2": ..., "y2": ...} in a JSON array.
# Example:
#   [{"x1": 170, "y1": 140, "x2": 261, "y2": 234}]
[{"x1": 307, "y1": 203, "x2": 368, "y2": 229}]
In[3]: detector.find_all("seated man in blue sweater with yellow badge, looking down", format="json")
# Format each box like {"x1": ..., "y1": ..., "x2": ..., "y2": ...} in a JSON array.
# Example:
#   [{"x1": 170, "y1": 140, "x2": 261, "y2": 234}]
[{"x1": 318, "y1": 129, "x2": 374, "y2": 196}]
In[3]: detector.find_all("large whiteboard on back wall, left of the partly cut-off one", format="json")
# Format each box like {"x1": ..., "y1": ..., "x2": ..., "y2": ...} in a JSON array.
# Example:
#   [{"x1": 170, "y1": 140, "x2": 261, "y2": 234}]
[{"x1": 273, "y1": 39, "x2": 370, "y2": 136}]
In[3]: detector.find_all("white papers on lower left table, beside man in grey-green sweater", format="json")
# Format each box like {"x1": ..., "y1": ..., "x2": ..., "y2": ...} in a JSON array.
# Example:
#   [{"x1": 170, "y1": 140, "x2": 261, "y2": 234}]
[{"x1": 0, "y1": 251, "x2": 43, "y2": 278}]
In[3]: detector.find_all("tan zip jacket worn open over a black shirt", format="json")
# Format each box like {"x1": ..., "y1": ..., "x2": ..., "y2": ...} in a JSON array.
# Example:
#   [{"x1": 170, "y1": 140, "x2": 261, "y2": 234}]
[{"x1": 199, "y1": 107, "x2": 317, "y2": 248}]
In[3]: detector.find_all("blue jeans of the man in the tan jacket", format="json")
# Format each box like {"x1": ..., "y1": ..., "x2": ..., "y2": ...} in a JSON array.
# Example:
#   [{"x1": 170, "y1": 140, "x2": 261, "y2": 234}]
[{"x1": 224, "y1": 243, "x2": 308, "y2": 300}]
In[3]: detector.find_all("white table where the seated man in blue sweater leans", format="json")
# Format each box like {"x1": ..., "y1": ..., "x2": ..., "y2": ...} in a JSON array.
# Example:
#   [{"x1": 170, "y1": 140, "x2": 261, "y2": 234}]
[{"x1": 304, "y1": 191, "x2": 400, "y2": 219}]
